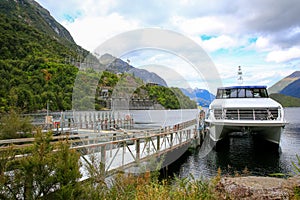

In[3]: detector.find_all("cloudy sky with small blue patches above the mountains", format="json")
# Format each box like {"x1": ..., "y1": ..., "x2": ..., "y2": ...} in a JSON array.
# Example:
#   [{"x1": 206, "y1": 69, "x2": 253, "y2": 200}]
[{"x1": 37, "y1": 0, "x2": 300, "y2": 91}]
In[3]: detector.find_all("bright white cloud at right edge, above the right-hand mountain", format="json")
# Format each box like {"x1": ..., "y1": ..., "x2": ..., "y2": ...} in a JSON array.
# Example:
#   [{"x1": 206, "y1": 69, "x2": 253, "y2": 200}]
[{"x1": 266, "y1": 47, "x2": 300, "y2": 63}]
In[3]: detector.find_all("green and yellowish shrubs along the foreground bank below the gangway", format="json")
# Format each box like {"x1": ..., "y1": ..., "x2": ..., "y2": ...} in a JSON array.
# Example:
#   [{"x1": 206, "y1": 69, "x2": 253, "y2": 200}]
[{"x1": 0, "y1": 144, "x2": 218, "y2": 200}]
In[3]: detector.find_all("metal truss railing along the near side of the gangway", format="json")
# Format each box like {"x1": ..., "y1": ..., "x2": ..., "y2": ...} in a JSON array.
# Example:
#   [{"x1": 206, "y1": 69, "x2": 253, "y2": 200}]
[{"x1": 72, "y1": 120, "x2": 196, "y2": 179}]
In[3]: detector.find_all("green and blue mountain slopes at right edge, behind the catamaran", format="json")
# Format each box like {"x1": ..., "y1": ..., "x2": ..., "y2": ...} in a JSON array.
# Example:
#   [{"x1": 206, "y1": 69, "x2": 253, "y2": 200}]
[{"x1": 268, "y1": 71, "x2": 300, "y2": 98}]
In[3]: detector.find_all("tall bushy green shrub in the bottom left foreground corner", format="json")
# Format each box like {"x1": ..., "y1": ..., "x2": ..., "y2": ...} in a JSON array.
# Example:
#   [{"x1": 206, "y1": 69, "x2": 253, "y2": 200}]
[{"x1": 0, "y1": 131, "x2": 81, "y2": 199}]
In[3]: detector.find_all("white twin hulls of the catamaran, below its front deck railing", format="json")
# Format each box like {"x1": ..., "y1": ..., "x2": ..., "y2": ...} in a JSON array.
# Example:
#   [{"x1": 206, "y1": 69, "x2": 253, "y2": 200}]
[{"x1": 208, "y1": 120, "x2": 285, "y2": 145}]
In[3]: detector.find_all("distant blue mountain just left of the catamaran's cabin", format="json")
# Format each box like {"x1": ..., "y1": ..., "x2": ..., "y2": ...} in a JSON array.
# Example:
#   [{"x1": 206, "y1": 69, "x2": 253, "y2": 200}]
[{"x1": 181, "y1": 88, "x2": 215, "y2": 107}]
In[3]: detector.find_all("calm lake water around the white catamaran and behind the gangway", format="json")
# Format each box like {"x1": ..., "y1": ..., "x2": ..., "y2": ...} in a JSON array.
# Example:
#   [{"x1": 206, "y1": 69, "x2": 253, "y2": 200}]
[{"x1": 131, "y1": 108, "x2": 300, "y2": 178}]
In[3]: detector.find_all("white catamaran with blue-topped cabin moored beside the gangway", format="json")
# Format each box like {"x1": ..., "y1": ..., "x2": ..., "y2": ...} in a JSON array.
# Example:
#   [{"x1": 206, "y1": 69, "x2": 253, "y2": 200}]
[{"x1": 205, "y1": 69, "x2": 287, "y2": 145}]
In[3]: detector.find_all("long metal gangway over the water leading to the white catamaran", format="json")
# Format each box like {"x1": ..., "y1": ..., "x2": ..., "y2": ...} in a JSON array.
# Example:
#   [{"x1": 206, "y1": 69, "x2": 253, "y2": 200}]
[{"x1": 71, "y1": 120, "x2": 201, "y2": 180}]
